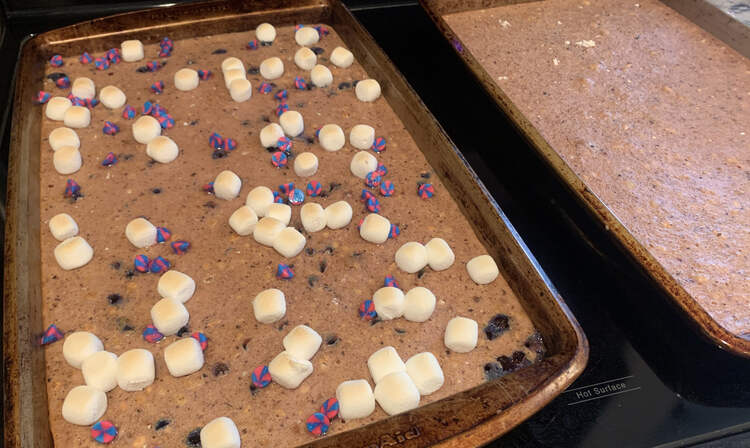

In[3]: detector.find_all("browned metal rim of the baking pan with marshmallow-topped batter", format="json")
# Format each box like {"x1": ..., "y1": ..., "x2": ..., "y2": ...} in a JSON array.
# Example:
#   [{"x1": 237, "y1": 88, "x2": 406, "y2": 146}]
[{"x1": 3, "y1": 0, "x2": 588, "y2": 447}]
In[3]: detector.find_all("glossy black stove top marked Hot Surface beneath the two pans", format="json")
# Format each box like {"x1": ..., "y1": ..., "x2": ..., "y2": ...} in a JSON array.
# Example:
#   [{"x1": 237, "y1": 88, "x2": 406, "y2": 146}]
[{"x1": 0, "y1": 0, "x2": 750, "y2": 448}]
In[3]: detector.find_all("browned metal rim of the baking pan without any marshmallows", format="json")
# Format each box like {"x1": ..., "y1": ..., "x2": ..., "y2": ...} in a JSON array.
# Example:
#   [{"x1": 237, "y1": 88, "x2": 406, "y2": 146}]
[{"x1": 420, "y1": 0, "x2": 750, "y2": 357}]
